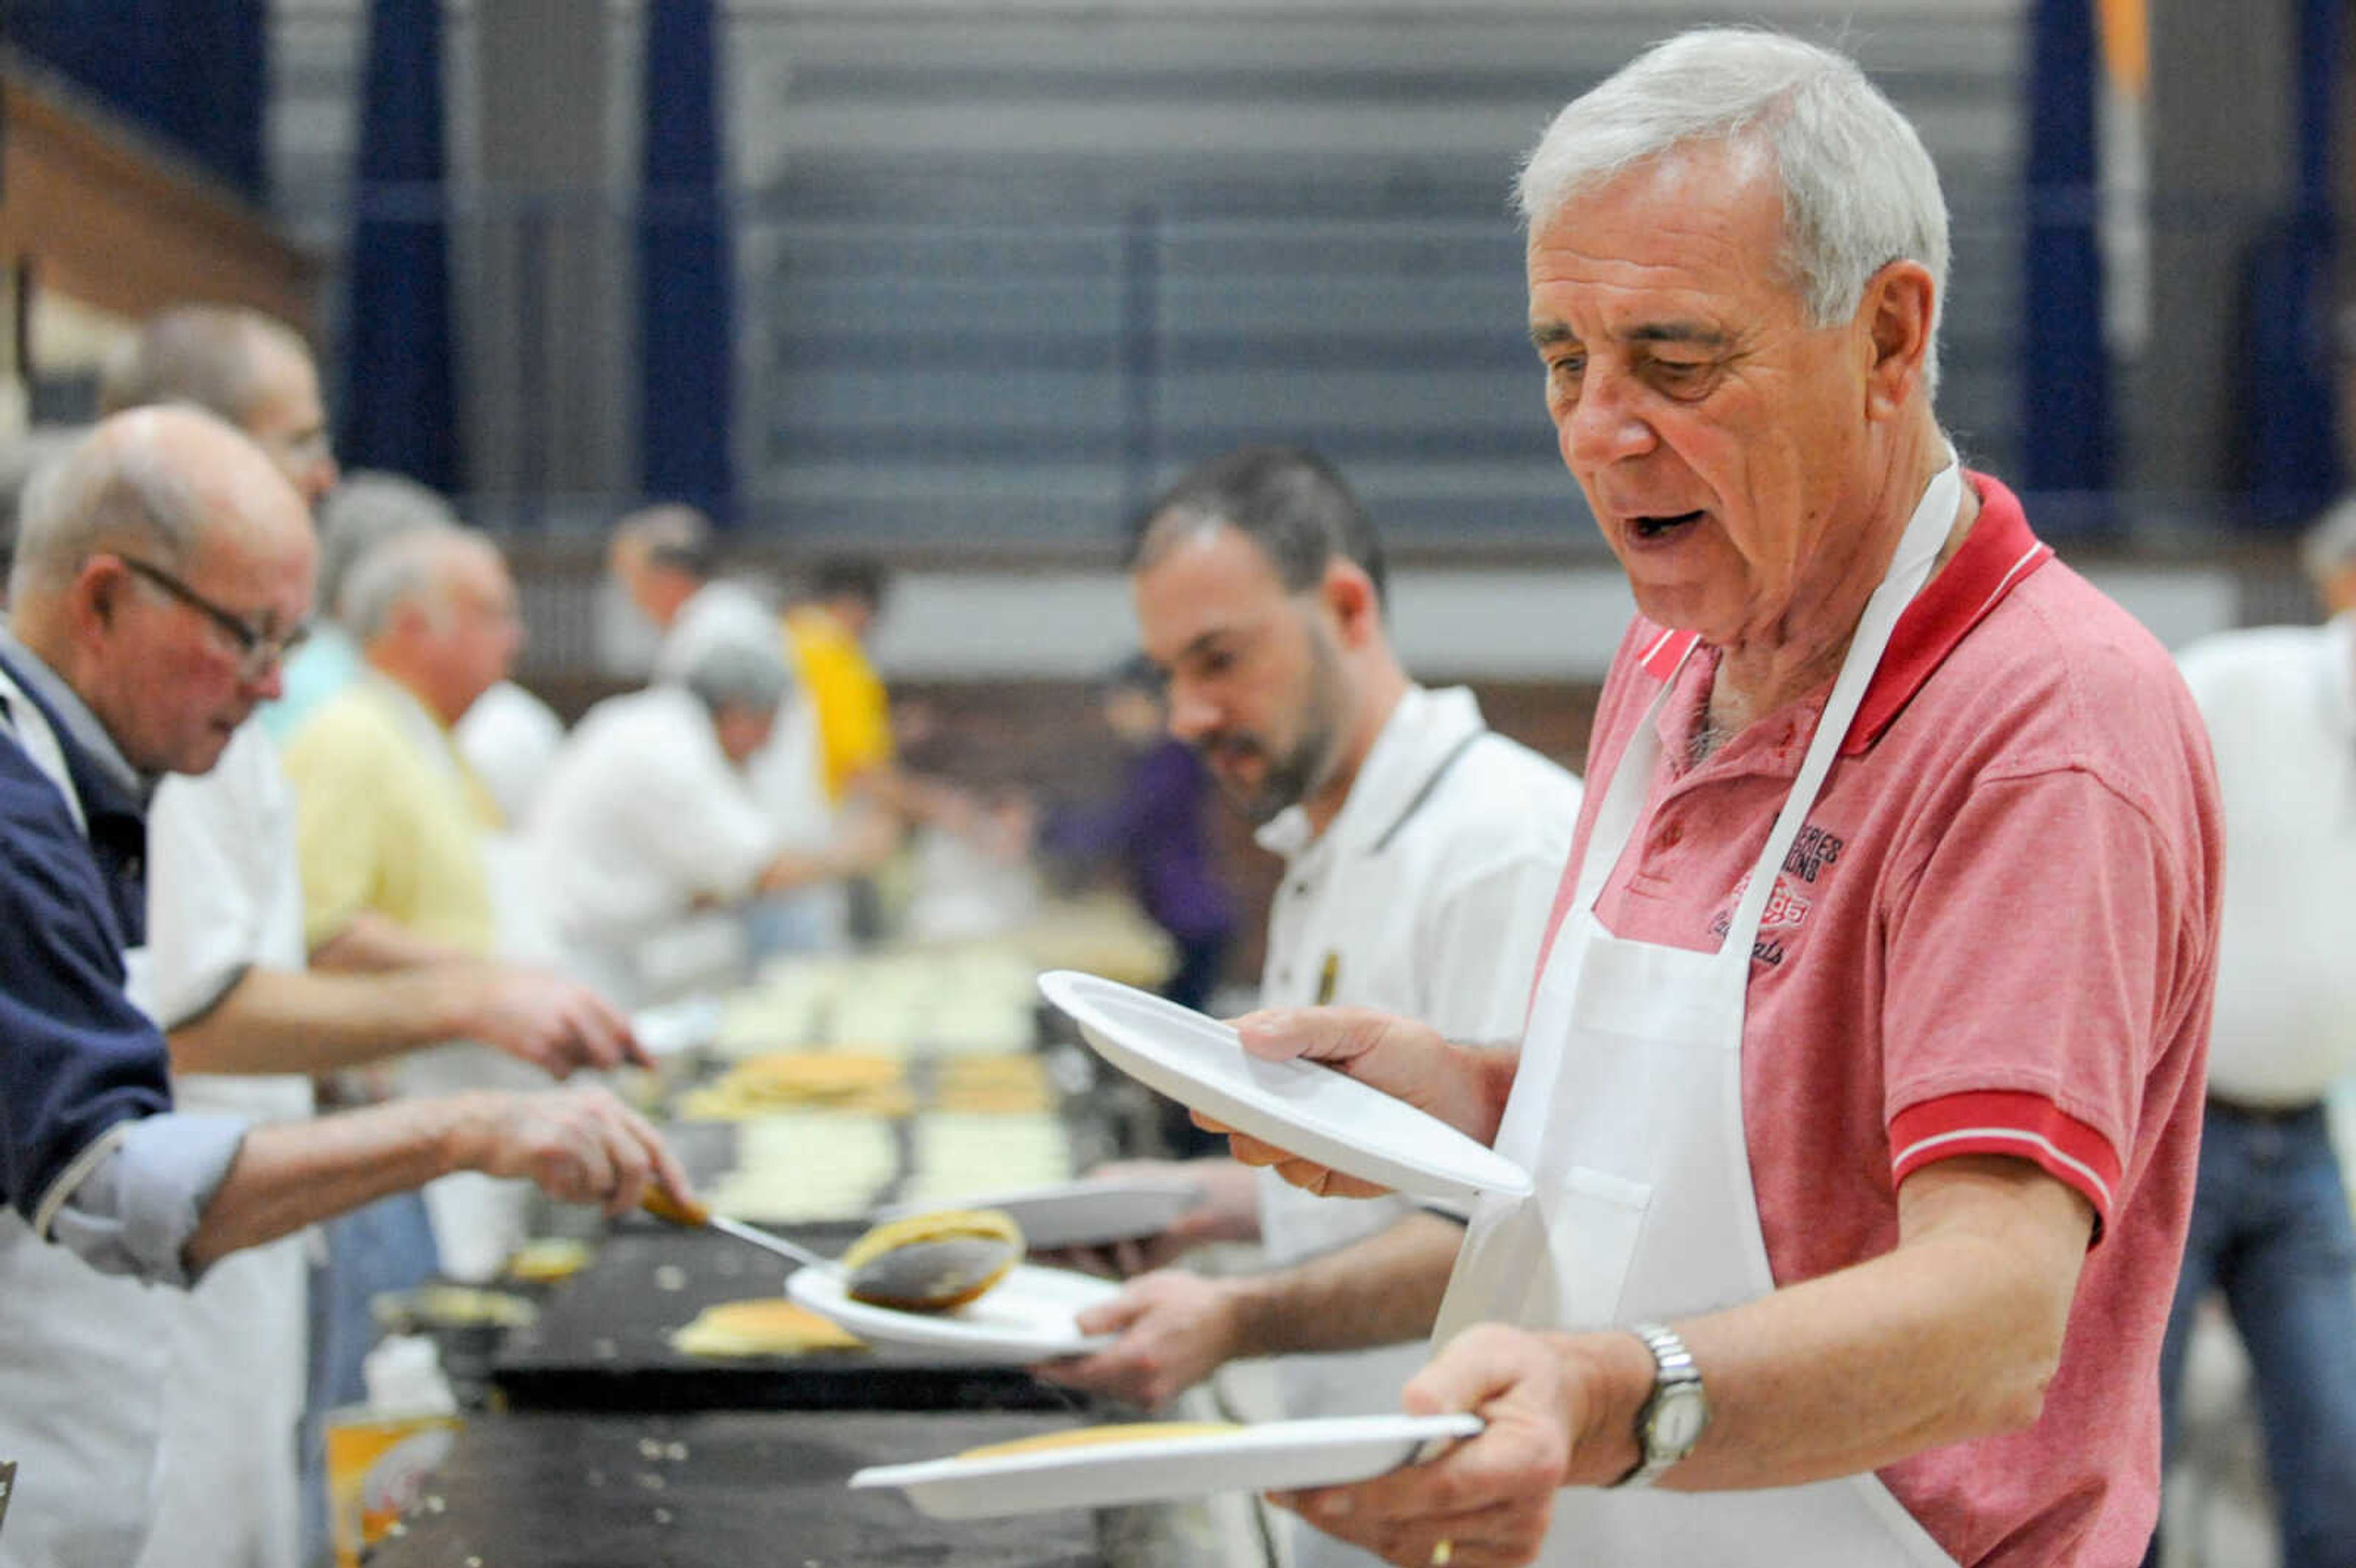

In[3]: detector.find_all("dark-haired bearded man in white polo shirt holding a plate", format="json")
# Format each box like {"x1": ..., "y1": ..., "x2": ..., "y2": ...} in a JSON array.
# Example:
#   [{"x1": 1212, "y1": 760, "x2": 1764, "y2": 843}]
[{"x1": 1044, "y1": 447, "x2": 1579, "y2": 1568}]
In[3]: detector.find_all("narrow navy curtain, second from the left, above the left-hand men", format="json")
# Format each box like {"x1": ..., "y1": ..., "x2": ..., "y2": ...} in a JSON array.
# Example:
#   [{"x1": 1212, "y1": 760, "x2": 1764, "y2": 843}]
[{"x1": 337, "y1": 0, "x2": 460, "y2": 492}]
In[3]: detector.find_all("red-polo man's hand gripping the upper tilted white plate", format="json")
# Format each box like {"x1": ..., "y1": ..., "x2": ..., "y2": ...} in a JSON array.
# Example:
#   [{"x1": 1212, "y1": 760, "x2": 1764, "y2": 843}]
[{"x1": 1195, "y1": 1008, "x2": 1496, "y2": 1198}]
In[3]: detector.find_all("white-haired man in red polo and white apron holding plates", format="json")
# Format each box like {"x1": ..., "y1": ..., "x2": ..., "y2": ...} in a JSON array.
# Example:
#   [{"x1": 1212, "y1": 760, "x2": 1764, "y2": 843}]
[{"x1": 1234, "y1": 28, "x2": 2224, "y2": 1568}]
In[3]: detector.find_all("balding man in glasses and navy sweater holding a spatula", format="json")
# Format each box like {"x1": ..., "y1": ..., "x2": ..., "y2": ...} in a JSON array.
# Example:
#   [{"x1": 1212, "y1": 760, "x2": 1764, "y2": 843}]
[{"x1": 0, "y1": 407, "x2": 681, "y2": 1568}]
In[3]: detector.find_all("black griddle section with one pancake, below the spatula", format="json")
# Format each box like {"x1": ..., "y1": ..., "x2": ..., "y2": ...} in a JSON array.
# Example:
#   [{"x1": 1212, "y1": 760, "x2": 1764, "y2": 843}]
[{"x1": 490, "y1": 1227, "x2": 1093, "y2": 1410}]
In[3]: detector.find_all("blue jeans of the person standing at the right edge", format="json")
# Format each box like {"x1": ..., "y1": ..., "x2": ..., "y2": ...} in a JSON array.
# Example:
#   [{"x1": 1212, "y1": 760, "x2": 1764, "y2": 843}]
[{"x1": 2146, "y1": 1099, "x2": 2356, "y2": 1568}]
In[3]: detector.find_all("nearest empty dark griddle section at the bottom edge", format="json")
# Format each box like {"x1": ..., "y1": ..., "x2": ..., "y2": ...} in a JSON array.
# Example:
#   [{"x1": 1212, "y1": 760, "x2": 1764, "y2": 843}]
[{"x1": 368, "y1": 1413, "x2": 1107, "y2": 1568}]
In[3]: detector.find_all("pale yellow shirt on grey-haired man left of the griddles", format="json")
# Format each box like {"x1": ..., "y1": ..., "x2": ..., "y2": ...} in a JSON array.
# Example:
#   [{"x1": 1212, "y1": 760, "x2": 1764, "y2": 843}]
[{"x1": 285, "y1": 675, "x2": 499, "y2": 958}]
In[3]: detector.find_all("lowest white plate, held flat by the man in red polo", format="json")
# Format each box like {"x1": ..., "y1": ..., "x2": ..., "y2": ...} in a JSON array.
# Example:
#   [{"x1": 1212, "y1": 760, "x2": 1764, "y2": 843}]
[{"x1": 850, "y1": 1415, "x2": 1482, "y2": 1518}]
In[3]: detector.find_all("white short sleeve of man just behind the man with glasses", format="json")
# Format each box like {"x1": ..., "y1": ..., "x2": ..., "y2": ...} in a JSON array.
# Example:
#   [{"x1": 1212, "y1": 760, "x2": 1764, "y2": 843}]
[{"x1": 148, "y1": 720, "x2": 304, "y2": 1029}]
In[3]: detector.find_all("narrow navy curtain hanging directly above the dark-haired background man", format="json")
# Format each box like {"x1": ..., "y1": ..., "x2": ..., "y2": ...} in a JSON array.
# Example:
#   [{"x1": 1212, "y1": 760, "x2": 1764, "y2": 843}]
[{"x1": 639, "y1": 0, "x2": 735, "y2": 523}]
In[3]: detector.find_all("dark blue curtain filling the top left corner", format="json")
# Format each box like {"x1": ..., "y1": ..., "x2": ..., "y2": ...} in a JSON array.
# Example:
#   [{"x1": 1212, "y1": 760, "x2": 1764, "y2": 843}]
[{"x1": 9, "y1": 0, "x2": 269, "y2": 202}]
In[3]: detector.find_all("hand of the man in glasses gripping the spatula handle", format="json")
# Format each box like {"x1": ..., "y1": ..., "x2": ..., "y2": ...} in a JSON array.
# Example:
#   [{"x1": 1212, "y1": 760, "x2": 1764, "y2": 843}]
[{"x1": 455, "y1": 1085, "x2": 695, "y2": 1215}]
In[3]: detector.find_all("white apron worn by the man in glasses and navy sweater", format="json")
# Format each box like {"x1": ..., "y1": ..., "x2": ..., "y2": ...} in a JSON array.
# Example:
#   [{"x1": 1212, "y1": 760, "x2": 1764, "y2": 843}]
[{"x1": 0, "y1": 674, "x2": 169, "y2": 1568}]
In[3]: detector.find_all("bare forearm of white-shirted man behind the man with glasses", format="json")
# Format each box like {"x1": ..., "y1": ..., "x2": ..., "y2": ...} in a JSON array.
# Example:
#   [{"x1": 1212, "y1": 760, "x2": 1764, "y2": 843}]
[{"x1": 169, "y1": 966, "x2": 474, "y2": 1074}]
